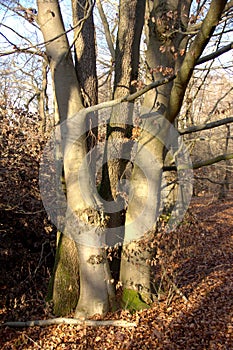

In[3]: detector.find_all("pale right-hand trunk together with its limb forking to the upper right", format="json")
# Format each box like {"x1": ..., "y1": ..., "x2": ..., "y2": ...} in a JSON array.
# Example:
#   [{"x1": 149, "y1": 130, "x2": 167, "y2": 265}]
[{"x1": 121, "y1": 0, "x2": 226, "y2": 306}]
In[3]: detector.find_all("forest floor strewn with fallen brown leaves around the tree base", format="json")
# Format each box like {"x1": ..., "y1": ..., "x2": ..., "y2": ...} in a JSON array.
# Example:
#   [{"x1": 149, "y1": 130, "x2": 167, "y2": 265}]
[{"x1": 0, "y1": 193, "x2": 233, "y2": 350}]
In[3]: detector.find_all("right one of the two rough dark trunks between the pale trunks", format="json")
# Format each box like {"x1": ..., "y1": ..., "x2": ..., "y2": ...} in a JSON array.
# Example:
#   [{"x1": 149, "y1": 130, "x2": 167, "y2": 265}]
[{"x1": 100, "y1": 0, "x2": 145, "y2": 244}]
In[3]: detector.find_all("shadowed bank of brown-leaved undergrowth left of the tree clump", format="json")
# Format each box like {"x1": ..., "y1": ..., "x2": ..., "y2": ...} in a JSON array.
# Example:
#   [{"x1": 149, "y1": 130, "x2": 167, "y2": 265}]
[{"x1": 0, "y1": 110, "x2": 55, "y2": 340}]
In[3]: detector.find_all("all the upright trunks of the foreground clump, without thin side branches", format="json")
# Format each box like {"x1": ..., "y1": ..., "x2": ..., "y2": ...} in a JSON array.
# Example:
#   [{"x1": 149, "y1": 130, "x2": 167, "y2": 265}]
[{"x1": 37, "y1": 0, "x2": 226, "y2": 317}]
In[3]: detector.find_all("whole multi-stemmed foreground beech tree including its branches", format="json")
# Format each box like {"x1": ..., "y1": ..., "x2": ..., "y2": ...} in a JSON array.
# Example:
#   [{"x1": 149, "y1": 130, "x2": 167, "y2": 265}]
[{"x1": 0, "y1": 0, "x2": 233, "y2": 318}]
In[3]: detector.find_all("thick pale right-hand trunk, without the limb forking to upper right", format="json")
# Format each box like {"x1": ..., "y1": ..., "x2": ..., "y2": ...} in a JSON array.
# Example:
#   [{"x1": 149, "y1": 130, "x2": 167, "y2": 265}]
[{"x1": 120, "y1": 1, "x2": 189, "y2": 308}]
